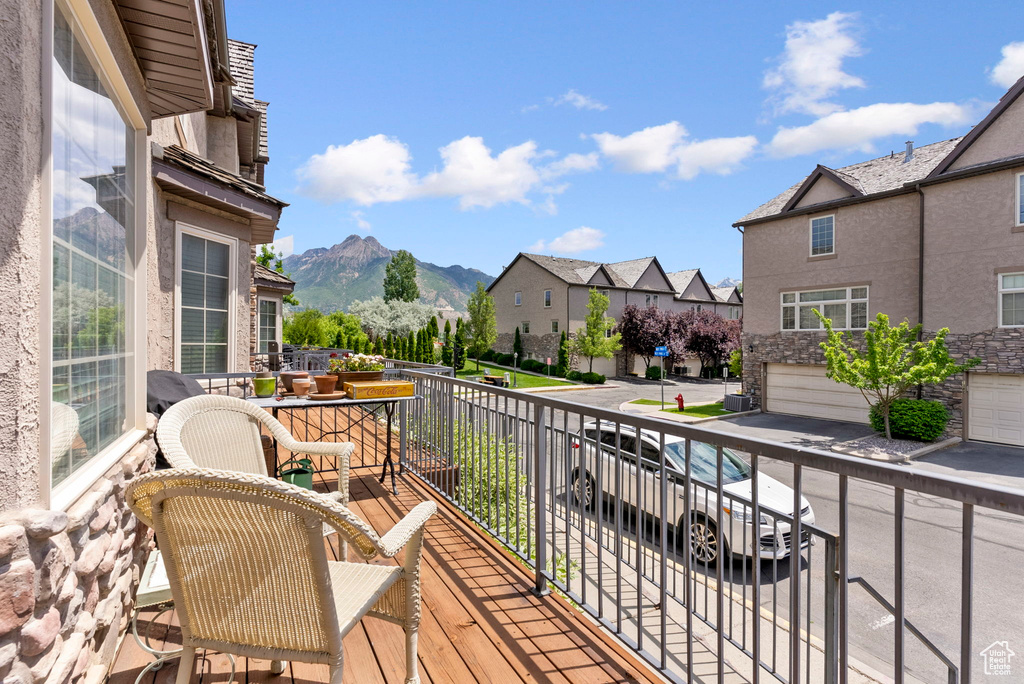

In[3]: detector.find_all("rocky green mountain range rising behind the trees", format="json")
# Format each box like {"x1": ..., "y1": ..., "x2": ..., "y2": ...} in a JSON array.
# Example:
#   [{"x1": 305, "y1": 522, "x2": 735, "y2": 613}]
[{"x1": 284, "y1": 236, "x2": 495, "y2": 312}]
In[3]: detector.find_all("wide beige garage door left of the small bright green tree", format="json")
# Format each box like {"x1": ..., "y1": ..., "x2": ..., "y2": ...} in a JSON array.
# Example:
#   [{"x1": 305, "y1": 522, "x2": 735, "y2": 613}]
[{"x1": 765, "y1": 364, "x2": 868, "y2": 423}]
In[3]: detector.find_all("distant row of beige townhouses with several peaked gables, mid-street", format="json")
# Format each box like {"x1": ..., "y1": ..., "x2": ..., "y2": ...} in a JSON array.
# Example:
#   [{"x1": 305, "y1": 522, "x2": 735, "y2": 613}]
[{"x1": 487, "y1": 253, "x2": 742, "y2": 376}]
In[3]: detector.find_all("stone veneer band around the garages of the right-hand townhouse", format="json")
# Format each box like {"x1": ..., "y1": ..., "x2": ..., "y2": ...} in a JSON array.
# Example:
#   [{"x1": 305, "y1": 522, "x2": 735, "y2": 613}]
[{"x1": 742, "y1": 328, "x2": 1007, "y2": 436}]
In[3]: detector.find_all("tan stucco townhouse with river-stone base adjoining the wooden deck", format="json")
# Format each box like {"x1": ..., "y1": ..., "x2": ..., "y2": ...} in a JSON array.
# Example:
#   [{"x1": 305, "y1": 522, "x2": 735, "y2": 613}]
[{"x1": 0, "y1": 0, "x2": 285, "y2": 682}]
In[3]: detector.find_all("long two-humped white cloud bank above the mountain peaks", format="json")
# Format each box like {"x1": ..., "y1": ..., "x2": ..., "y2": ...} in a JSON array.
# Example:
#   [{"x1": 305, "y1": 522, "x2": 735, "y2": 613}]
[{"x1": 298, "y1": 134, "x2": 598, "y2": 208}]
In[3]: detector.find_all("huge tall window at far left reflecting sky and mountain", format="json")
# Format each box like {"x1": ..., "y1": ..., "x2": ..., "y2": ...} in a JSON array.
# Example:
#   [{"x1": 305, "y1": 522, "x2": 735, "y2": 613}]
[{"x1": 49, "y1": 3, "x2": 140, "y2": 490}]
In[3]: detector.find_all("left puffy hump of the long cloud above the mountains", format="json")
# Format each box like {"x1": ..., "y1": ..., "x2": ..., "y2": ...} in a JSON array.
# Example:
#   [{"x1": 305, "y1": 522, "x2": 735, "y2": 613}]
[{"x1": 299, "y1": 134, "x2": 416, "y2": 206}]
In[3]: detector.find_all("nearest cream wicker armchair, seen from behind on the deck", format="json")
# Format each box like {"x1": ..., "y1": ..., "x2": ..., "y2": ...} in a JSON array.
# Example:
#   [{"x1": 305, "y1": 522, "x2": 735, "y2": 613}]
[{"x1": 127, "y1": 468, "x2": 437, "y2": 684}]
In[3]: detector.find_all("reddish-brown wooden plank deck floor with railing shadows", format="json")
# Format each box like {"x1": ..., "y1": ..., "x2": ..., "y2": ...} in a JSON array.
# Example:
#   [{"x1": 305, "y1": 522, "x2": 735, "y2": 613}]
[{"x1": 110, "y1": 403, "x2": 662, "y2": 684}]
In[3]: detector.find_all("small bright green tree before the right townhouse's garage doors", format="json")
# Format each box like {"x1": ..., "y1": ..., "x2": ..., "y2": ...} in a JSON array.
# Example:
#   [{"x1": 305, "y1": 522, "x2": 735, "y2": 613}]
[{"x1": 814, "y1": 309, "x2": 981, "y2": 439}]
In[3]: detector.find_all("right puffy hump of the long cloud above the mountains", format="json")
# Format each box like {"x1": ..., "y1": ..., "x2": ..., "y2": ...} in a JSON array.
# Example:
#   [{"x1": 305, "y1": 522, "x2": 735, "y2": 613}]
[{"x1": 421, "y1": 136, "x2": 541, "y2": 209}]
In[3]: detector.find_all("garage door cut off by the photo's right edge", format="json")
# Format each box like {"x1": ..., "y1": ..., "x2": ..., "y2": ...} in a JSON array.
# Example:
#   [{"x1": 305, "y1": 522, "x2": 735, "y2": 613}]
[{"x1": 968, "y1": 373, "x2": 1024, "y2": 445}]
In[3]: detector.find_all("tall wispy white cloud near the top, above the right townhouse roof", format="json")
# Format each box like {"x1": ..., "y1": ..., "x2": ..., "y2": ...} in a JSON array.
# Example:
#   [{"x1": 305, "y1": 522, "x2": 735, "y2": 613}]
[{"x1": 764, "y1": 12, "x2": 864, "y2": 117}]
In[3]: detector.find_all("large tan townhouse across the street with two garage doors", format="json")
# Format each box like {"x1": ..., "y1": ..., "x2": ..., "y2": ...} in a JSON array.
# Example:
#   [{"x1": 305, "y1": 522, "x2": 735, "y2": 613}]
[{"x1": 734, "y1": 79, "x2": 1024, "y2": 445}]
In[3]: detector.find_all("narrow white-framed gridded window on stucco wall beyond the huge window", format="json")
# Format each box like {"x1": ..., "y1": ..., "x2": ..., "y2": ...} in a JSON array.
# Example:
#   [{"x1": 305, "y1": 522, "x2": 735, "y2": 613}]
[{"x1": 177, "y1": 226, "x2": 236, "y2": 373}]
